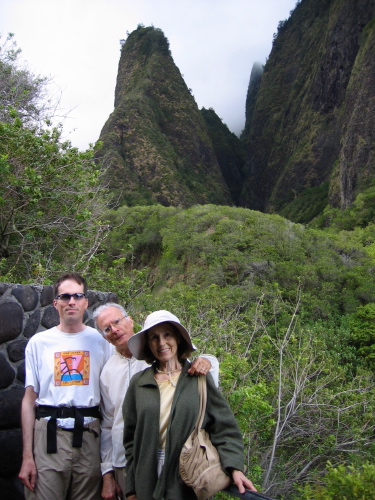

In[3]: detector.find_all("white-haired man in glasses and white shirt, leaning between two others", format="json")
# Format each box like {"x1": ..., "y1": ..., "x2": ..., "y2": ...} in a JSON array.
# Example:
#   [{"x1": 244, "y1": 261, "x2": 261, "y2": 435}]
[{"x1": 93, "y1": 303, "x2": 219, "y2": 500}]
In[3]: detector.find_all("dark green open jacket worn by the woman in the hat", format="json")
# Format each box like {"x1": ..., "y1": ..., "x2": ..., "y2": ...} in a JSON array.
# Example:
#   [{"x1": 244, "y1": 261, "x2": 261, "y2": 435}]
[{"x1": 123, "y1": 362, "x2": 244, "y2": 500}]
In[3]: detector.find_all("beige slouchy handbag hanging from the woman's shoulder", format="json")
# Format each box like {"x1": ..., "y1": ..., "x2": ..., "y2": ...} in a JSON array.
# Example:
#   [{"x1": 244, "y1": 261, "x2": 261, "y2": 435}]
[{"x1": 180, "y1": 375, "x2": 231, "y2": 500}]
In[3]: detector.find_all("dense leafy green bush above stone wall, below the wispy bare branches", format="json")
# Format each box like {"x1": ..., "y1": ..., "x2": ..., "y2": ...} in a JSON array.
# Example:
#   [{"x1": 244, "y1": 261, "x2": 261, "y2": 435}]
[{"x1": 0, "y1": 118, "x2": 107, "y2": 281}]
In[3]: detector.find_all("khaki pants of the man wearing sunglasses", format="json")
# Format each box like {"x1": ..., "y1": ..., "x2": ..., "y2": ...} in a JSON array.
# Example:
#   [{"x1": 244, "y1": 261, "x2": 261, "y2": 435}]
[{"x1": 25, "y1": 418, "x2": 102, "y2": 500}]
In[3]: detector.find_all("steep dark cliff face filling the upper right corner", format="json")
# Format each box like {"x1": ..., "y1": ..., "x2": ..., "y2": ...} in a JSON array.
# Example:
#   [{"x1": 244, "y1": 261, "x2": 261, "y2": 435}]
[{"x1": 240, "y1": 0, "x2": 375, "y2": 222}]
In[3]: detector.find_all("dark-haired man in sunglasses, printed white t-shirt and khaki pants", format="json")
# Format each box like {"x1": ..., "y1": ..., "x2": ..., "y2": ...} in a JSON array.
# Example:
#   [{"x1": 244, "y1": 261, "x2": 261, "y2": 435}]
[{"x1": 19, "y1": 273, "x2": 113, "y2": 500}]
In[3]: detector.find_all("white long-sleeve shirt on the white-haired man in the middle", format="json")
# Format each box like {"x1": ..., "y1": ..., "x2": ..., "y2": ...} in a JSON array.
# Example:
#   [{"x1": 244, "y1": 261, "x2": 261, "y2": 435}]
[{"x1": 100, "y1": 351, "x2": 219, "y2": 474}]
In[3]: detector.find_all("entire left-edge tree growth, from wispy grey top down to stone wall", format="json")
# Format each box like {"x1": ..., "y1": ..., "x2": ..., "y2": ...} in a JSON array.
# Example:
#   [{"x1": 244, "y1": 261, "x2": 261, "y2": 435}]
[{"x1": 0, "y1": 35, "x2": 110, "y2": 283}]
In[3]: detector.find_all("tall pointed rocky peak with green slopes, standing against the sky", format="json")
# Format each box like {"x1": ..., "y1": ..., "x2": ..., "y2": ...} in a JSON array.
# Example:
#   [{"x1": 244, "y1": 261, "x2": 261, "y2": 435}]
[{"x1": 98, "y1": 26, "x2": 231, "y2": 206}]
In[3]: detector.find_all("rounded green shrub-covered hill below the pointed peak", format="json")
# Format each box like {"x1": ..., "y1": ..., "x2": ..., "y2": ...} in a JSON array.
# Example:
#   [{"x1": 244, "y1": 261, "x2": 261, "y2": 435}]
[{"x1": 102, "y1": 205, "x2": 375, "y2": 319}]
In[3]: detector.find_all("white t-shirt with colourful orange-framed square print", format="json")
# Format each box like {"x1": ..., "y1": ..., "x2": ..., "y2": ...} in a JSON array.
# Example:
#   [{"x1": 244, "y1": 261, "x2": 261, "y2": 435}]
[{"x1": 25, "y1": 327, "x2": 113, "y2": 427}]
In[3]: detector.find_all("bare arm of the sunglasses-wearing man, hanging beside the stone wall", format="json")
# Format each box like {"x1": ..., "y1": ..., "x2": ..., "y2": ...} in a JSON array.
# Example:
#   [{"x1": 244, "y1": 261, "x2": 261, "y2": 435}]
[{"x1": 18, "y1": 386, "x2": 38, "y2": 491}]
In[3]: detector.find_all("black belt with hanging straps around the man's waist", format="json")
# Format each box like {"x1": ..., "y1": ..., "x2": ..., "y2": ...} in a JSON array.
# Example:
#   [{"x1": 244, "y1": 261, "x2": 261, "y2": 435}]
[{"x1": 35, "y1": 405, "x2": 101, "y2": 453}]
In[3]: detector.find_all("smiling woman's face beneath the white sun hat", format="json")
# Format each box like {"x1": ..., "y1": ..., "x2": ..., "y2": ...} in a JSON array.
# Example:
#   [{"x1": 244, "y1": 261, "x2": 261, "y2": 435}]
[{"x1": 148, "y1": 323, "x2": 178, "y2": 365}]
